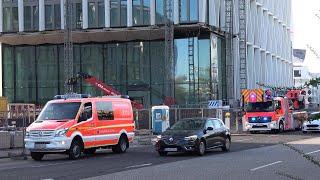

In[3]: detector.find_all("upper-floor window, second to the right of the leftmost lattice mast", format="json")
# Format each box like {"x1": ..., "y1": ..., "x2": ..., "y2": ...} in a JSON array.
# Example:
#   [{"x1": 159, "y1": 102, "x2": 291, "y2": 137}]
[{"x1": 88, "y1": 0, "x2": 104, "y2": 28}]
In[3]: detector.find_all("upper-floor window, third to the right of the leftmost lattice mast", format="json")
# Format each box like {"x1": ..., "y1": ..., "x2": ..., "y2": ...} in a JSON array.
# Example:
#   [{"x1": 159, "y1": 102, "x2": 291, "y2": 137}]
[{"x1": 110, "y1": 0, "x2": 127, "y2": 27}]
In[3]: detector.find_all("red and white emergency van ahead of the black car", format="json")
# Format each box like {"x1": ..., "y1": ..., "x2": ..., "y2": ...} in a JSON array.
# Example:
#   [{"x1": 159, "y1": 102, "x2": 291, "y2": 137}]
[{"x1": 25, "y1": 95, "x2": 135, "y2": 160}]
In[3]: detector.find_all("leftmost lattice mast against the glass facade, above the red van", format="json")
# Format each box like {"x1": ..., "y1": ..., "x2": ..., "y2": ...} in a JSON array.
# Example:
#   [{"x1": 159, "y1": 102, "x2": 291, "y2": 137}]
[{"x1": 64, "y1": 0, "x2": 74, "y2": 93}]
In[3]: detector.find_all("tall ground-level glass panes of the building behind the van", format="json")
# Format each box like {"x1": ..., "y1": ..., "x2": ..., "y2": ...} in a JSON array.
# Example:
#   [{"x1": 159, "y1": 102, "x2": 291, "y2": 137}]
[{"x1": 2, "y1": 37, "x2": 222, "y2": 105}]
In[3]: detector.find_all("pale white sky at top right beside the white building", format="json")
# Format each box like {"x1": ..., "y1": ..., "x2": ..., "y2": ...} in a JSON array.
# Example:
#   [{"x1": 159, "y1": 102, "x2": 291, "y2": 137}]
[{"x1": 292, "y1": 0, "x2": 320, "y2": 73}]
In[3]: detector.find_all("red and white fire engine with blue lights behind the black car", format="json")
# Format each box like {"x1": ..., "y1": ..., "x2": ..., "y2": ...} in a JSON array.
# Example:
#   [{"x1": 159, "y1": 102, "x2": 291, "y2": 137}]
[{"x1": 243, "y1": 91, "x2": 299, "y2": 133}]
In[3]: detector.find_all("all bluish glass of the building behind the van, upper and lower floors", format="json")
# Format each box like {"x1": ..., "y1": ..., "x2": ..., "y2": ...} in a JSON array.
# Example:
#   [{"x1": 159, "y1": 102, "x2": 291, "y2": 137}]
[{"x1": 1, "y1": 0, "x2": 226, "y2": 107}]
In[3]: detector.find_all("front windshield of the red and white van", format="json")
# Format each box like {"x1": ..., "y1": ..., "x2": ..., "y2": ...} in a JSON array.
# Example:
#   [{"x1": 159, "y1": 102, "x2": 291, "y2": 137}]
[{"x1": 38, "y1": 102, "x2": 81, "y2": 120}]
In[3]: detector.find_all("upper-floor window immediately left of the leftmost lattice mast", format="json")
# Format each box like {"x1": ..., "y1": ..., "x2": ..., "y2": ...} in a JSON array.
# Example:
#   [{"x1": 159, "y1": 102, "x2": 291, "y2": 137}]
[{"x1": 45, "y1": 0, "x2": 61, "y2": 30}]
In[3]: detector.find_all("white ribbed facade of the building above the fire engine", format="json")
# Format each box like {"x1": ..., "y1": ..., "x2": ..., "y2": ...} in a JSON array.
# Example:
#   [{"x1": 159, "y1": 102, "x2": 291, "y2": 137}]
[{"x1": 235, "y1": 0, "x2": 293, "y2": 100}]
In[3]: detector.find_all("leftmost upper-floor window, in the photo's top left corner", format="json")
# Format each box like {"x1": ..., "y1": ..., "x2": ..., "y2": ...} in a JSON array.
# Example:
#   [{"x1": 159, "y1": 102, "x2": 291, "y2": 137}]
[{"x1": 3, "y1": 0, "x2": 19, "y2": 32}]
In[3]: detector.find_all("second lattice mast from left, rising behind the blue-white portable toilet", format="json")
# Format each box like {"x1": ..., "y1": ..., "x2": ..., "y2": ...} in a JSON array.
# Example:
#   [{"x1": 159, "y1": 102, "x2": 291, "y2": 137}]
[{"x1": 164, "y1": 0, "x2": 175, "y2": 97}]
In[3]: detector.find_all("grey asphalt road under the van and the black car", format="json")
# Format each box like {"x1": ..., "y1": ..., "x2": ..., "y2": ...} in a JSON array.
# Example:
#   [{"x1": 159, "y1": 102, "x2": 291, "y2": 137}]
[{"x1": 0, "y1": 132, "x2": 320, "y2": 180}]
